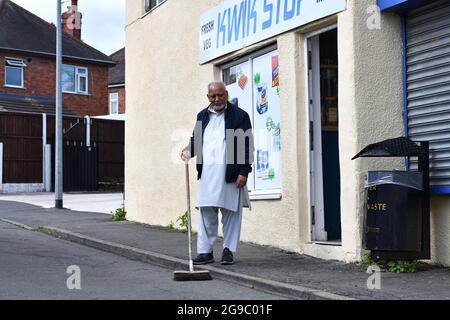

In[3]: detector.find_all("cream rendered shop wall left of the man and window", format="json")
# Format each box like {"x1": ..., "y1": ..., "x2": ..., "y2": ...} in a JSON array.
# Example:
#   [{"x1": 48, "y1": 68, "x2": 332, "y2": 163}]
[{"x1": 125, "y1": 0, "x2": 220, "y2": 230}]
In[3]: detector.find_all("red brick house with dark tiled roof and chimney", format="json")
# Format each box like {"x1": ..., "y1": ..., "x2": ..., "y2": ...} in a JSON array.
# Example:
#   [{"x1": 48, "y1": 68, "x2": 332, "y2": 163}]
[{"x1": 0, "y1": 0, "x2": 115, "y2": 117}]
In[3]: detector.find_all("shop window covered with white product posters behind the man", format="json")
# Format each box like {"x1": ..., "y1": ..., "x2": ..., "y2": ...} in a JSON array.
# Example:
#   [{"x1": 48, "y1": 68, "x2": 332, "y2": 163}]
[{"x1": 222, "y1": 49, "x2": 282, "y2": 196}]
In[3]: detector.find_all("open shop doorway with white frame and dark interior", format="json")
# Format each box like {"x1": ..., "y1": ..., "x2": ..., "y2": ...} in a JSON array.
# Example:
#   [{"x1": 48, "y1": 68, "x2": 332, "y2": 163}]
[{"x1": 306, "y1": 28, "x2": 341, "y2": 244}]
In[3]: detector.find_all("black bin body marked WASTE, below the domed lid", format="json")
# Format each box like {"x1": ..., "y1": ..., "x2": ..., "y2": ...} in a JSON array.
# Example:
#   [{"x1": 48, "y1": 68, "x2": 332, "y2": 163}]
[{"x1": 363, "y1": 171, "x2": 423, "y2": 251}]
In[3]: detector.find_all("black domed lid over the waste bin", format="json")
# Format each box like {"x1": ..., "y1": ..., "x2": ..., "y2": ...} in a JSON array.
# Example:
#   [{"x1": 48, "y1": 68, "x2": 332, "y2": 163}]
[{"x1": 352, "y1": 137, "x2": 425, "y2": 160}]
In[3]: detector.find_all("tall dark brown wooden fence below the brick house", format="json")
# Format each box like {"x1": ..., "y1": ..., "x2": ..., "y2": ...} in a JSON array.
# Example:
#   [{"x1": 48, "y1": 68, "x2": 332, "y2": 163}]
[{"x1": 0, "y1": 112, "x2": 125, "y2": 189}]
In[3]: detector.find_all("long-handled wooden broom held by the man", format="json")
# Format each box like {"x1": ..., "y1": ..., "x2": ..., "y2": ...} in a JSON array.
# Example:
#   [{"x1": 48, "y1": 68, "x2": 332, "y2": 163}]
[{"x1": 173, "y1": 160, "x2": 212, "y2": 281}]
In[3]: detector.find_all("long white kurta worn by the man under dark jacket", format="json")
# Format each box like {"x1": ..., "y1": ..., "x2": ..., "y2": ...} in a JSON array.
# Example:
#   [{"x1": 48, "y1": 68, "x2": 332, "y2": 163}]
[{"x1": 196, "y1": 108, "x2": 250, "y2": 212}]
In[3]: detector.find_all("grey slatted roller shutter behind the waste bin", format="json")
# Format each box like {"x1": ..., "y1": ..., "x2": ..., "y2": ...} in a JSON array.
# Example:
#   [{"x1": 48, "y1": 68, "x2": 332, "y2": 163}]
[{"x1": 406, "y1": 1, "x2": 450, "y2": 190}]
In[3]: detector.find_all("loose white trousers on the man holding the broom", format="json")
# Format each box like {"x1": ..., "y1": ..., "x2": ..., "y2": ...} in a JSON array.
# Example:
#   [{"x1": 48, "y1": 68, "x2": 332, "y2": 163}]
[{"x1": 197, "y1": 205, "x2": 242, "y2": 254}]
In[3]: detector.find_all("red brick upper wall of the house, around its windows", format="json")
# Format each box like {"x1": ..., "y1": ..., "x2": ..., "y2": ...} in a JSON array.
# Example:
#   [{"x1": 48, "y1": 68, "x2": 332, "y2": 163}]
[{"x1": 0, "y1": 52, "x2": 109, "y2": 116}]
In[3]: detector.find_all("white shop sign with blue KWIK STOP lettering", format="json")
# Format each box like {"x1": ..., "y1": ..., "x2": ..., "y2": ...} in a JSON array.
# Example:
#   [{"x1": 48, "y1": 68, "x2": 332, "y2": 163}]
[{"x1": 199, "y1": 0, "x2": 347, "y2": 64}]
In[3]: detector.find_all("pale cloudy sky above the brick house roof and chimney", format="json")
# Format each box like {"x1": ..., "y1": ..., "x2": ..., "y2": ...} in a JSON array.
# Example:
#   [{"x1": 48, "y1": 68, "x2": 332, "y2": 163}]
[{"x1": 12, "y1": 0, "x2": 125, "y2": 55}]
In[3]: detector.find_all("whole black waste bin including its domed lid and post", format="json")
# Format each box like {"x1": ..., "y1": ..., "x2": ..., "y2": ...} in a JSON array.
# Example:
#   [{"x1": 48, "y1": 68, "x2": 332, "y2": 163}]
[{"x1": 352, "y1": 137, "x2": 430, "y2": 260}]
